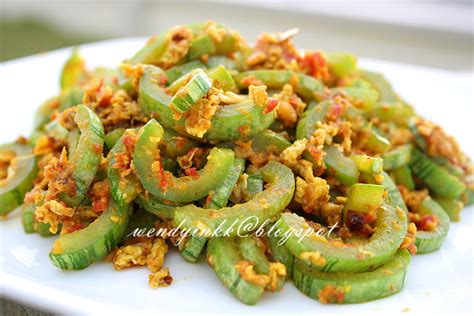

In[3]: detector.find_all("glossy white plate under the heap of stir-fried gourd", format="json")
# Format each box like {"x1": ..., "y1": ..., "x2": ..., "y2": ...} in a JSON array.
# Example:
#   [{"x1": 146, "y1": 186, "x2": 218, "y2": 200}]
[{"x1": 0, "y1": 39, "x2": 474, "y2": 314}]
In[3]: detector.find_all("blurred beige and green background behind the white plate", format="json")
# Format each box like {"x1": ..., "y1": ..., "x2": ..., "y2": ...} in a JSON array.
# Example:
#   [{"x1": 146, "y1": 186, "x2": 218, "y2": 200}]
[{"x1": 0, "y1": 0, "x2": 474, "y2": 72}]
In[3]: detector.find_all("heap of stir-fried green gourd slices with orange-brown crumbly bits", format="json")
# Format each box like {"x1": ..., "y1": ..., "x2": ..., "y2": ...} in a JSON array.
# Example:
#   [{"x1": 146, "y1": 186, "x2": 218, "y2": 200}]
[{"x1": 0, "y1": 21, "x2": 474, "y2": 304}]
